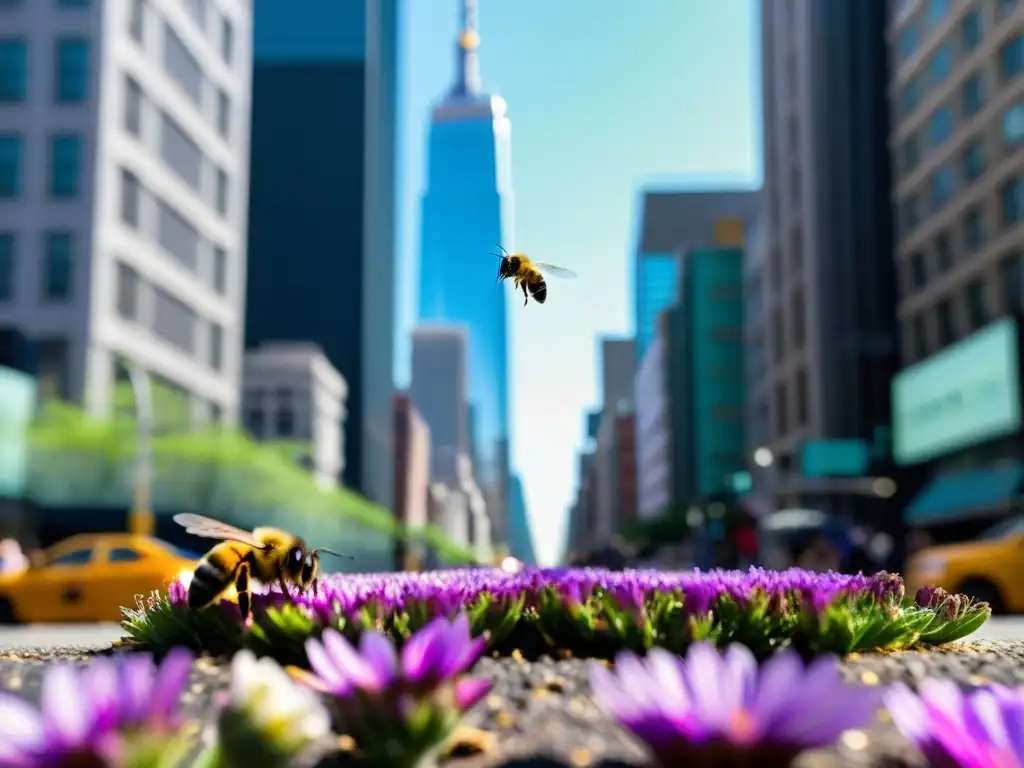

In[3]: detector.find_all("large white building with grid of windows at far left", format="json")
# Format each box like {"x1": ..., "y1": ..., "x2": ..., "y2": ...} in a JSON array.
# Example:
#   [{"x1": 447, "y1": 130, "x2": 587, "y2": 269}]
[{"x1": 0, "y1": 0, "x2": 252, "y2": 419}]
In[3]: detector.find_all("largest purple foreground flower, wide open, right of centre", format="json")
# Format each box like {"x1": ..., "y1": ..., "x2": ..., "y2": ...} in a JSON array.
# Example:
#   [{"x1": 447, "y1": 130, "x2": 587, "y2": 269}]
[{"x1": 591, "y1": 643, "x2": 879, "y2": 766}]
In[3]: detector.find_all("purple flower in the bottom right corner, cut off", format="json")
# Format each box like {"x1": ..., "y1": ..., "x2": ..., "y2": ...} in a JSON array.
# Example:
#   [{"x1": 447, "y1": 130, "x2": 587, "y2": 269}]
[{"x1": 885, "y1": 679, "x2": 1024, "y2": 768}]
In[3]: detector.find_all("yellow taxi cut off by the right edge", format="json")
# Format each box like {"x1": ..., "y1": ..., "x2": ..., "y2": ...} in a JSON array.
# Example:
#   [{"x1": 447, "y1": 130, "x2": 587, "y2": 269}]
[{"x1": 905, "y1": 515, "x2": 1024, "y2": 613}]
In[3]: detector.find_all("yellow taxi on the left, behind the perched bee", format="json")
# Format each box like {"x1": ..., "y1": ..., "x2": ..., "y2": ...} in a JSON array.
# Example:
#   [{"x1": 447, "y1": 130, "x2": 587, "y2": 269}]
[{"x1": 0, "y1": 534, "x2": 198, "y2": 623}]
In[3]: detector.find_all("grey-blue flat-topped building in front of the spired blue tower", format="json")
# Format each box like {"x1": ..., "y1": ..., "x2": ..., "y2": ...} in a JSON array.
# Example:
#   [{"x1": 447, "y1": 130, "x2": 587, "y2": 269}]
[{"x1": 409, "y1": 326, "x2": 471, "y2": 482}]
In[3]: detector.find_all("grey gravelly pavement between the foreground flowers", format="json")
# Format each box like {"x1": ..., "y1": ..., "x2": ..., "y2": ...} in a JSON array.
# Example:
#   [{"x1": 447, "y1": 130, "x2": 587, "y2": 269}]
[{"x1": 0, "y1": 640, "x2": 1024, "y2": 768}]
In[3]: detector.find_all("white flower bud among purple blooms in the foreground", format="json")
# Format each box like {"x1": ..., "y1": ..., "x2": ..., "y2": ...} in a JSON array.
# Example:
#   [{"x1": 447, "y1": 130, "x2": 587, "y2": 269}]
[{"x1": 230, "y1": 650, "x2": 331, "y2": 753}]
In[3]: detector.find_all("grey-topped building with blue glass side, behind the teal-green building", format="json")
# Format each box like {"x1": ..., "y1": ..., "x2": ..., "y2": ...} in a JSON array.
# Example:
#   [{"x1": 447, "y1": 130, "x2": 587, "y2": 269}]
[{"x1": 634, "y1": 190, "x2": 757, "y2": 362}]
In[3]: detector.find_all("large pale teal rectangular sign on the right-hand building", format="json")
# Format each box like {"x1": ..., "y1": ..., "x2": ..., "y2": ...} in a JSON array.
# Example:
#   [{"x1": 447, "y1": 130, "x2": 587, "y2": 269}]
[{"x1": 893, "y1": 317, "x2": 1021, "y2": 466}]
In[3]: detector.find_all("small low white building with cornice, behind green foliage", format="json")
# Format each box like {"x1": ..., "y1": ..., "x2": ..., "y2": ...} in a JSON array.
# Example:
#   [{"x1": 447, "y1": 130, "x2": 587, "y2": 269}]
[{"x1": 242, "y1": 342, "x2": 348, "y2": 486}]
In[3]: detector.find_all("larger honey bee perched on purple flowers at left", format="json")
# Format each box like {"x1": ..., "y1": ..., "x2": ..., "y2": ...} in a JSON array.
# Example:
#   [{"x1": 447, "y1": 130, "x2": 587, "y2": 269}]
[{"x1": 174, "y1": 513, "x2": 347, "y2": 621}]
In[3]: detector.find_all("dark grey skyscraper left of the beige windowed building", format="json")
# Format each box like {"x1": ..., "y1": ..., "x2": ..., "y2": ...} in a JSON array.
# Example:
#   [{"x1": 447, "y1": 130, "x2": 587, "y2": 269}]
[{"x1": 752, "y1": 0, "x2": 897, "y2": 513}]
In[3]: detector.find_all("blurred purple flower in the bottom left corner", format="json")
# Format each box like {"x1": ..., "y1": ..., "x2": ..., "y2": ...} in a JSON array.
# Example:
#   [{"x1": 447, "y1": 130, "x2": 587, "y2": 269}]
[{"x1": 0, "y1": 650, "x2": 193, "y2": 768}]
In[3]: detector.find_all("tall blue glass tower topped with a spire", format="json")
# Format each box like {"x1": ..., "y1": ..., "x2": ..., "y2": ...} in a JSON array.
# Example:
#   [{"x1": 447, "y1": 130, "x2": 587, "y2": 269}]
[{"x1": 419, "y1": 0, "x2": 513, "y2": 557}]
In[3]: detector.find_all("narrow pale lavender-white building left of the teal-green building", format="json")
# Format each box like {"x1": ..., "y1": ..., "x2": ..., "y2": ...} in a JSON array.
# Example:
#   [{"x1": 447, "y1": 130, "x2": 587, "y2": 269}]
[{"x1": 633, "y1": 331, "x2": 672, "y2": 520}]
